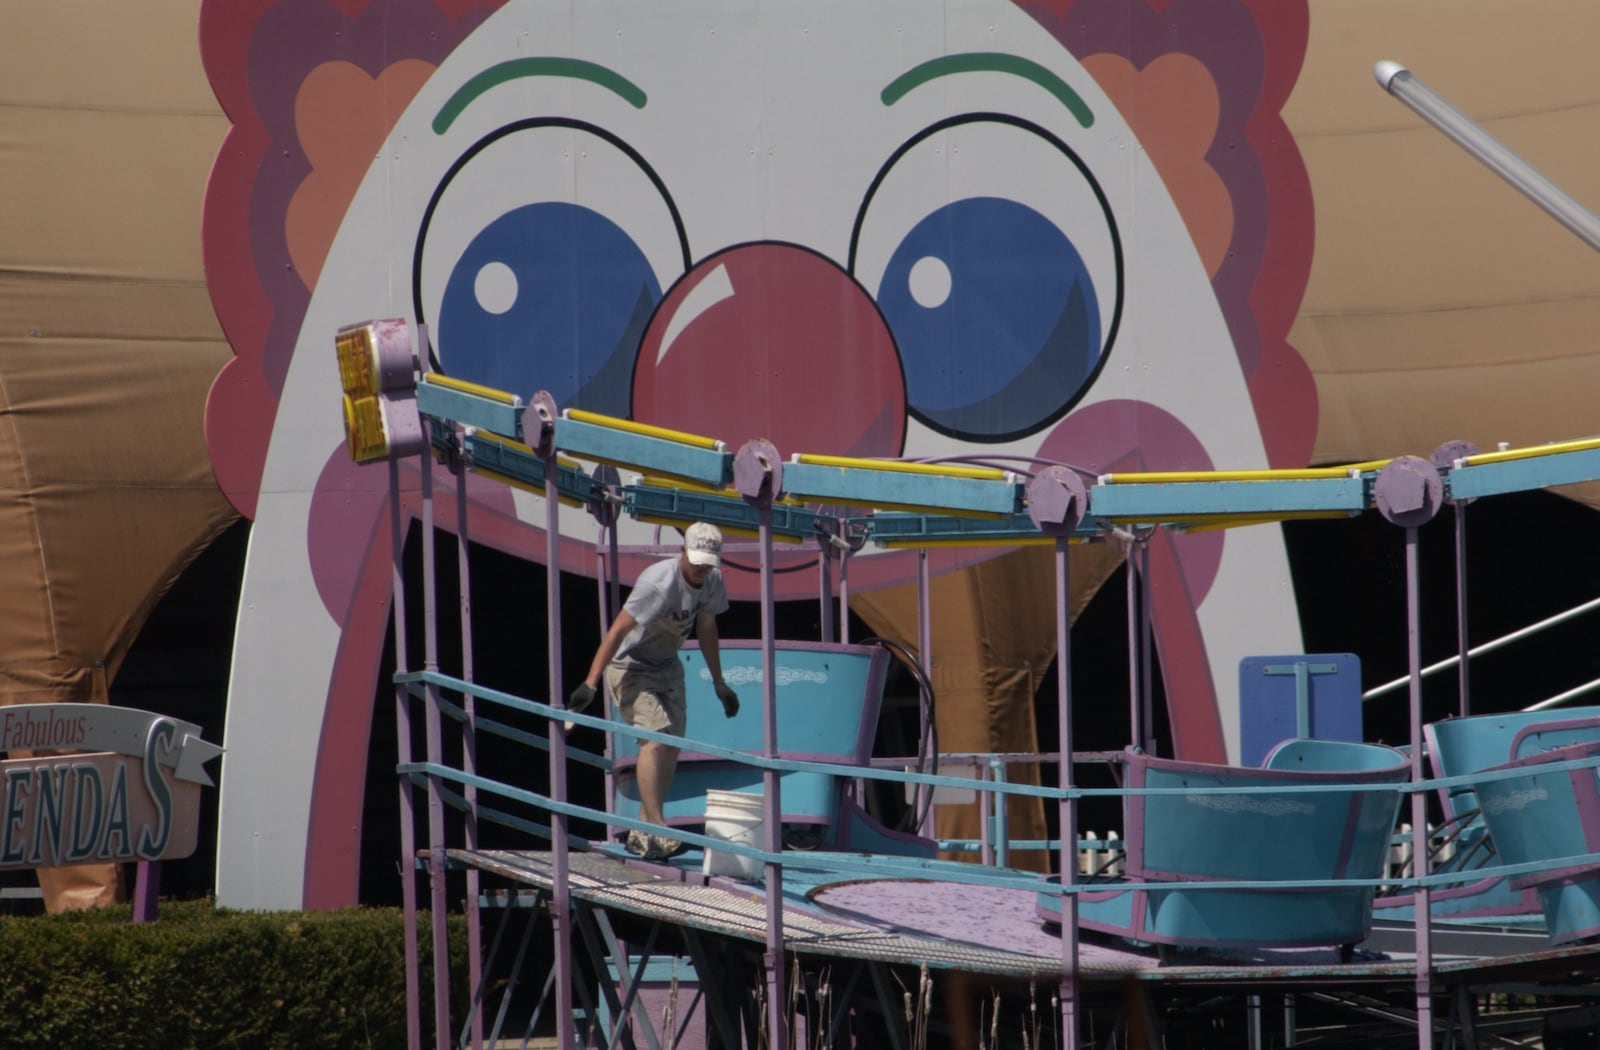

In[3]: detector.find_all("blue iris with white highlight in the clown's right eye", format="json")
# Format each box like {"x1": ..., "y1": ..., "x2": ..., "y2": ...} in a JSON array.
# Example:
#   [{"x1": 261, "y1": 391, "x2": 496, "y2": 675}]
[{"x1": 878, "y1": 197, "x2": 1101, "y2": 439}]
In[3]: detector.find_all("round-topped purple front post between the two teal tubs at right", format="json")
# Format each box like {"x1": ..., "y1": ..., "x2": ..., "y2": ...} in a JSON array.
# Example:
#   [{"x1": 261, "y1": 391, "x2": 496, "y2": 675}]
[{"x1": 1373, "y1": 456, "x2": 1445, "y2": 1050}]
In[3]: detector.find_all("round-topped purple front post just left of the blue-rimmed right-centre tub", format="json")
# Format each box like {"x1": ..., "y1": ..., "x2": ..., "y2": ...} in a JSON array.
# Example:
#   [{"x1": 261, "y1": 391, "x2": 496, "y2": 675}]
[{"x1": 1027, "y1": 466, "x2": 1088, "y2": 1050}]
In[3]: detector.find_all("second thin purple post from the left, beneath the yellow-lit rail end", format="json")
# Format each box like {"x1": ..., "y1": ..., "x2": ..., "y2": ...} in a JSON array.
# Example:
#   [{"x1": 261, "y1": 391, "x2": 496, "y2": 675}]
[{"x1": 421, "y1": 448, "x2": 450, "y2": 1050}]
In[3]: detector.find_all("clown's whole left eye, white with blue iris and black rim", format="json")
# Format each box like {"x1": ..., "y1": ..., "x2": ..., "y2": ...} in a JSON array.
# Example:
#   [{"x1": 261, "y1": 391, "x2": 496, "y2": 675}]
[{"x1": 411, "y1": 118, "x2": 688, "y2": 416}]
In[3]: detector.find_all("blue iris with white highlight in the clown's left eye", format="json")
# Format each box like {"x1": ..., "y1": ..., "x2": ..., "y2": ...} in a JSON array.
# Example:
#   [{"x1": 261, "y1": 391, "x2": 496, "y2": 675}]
[{"x1": 437, "y1": 202, "x2": 661, "y2": 416}]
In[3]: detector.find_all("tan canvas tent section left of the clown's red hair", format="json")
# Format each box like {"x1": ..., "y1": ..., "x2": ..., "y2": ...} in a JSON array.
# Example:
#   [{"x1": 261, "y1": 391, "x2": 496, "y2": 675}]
[{"x1": 0, "y1": 0, "x2": 235, "y2": 911}]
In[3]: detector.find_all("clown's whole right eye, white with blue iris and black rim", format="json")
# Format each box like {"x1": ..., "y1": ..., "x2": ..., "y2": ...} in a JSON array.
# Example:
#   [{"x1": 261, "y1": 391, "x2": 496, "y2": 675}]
[{"x1": 850, "y1": 114, "x2": 1123, "y2": 443}]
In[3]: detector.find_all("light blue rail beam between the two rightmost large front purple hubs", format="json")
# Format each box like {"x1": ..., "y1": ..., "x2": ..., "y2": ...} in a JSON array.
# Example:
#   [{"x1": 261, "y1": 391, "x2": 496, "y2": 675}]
[{"x1": 1090, "y1": 477, "x2": 1366, "y2": 523}]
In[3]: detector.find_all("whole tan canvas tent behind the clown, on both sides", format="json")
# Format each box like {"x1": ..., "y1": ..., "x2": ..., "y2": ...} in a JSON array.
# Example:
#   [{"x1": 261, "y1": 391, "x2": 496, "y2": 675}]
[{"x1": 0, "y1": 0, "x2": 1600, "y2": 906}]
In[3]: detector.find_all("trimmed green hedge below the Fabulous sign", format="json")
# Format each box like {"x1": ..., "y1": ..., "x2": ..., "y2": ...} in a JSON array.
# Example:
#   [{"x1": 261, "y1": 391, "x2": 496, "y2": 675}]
[{"x1": 0, "y1": 901, "x2": 469, "y2": 1050}]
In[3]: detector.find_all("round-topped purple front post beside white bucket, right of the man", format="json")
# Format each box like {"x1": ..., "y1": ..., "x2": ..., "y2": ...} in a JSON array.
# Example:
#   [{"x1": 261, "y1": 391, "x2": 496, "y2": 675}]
[{"x1": 733, "y1": 440, "x2": 789, "y2": 1047}]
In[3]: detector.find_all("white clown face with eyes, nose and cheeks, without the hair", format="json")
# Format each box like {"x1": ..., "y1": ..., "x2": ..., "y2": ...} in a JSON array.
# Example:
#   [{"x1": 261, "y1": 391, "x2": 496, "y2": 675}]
[{"x1": 206, "y1": 2, "x2": 1299, "y2": 908}]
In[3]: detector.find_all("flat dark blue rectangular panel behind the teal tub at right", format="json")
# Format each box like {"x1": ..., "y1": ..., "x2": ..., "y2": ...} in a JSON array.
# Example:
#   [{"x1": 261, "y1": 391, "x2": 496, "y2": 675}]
[{"x1": 1238, "y1": 653, "x2": 1362, "y2": 767}]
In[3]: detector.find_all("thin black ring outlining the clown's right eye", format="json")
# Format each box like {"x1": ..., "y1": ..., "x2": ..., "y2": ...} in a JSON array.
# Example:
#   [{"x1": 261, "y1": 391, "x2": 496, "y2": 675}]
[{"x1": 846, "y1": 112, "x2": 1126, "y2": 445}]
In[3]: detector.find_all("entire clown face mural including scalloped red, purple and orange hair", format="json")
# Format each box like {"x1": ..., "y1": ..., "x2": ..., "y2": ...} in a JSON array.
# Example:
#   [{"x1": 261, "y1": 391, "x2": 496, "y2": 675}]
[{"x1": 202, "y1": 0, "x2": 1315, "y2": 908}]
